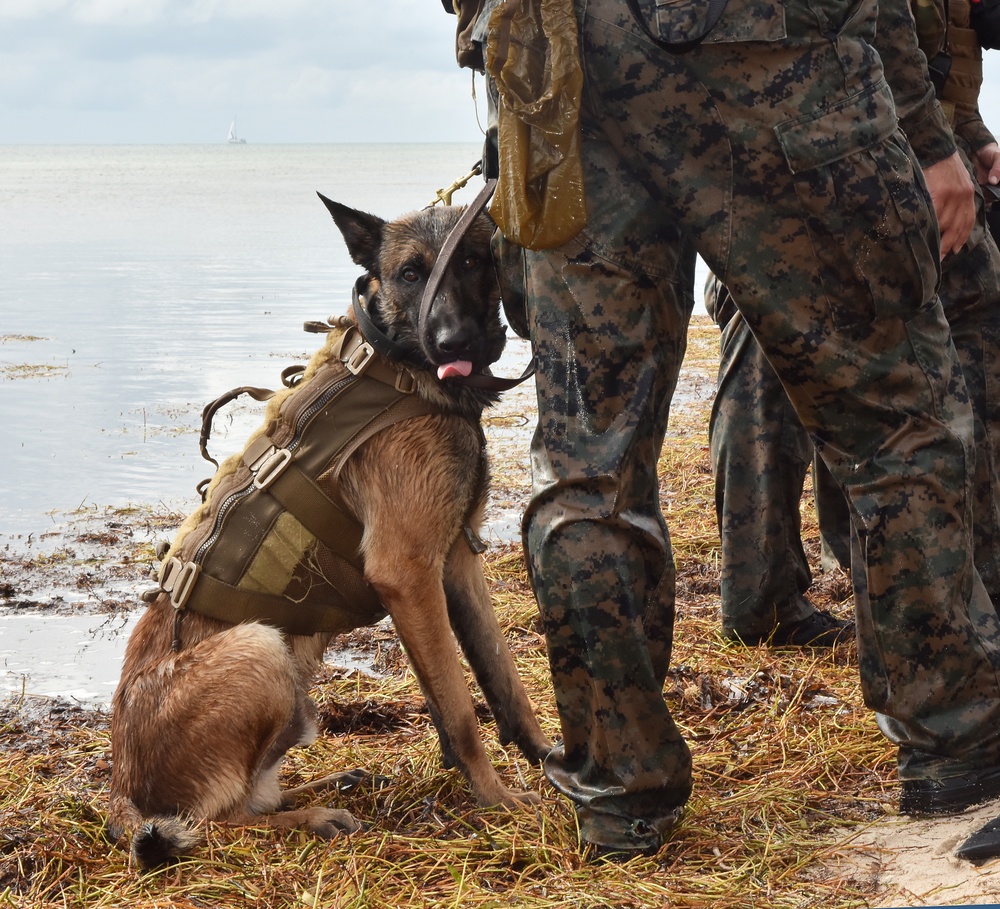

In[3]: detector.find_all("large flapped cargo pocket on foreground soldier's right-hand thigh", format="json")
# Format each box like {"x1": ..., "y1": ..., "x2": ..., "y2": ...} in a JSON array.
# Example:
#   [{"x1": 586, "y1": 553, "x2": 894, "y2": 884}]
[{"x1": 774, "y1": 79, "x2": 940, "y2": 331}]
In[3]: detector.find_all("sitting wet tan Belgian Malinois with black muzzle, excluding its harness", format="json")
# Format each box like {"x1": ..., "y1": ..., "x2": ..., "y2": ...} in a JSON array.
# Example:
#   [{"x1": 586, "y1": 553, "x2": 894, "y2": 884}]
[{"x1": 109, "y1": 196, "x2": 551, "y2": 867}]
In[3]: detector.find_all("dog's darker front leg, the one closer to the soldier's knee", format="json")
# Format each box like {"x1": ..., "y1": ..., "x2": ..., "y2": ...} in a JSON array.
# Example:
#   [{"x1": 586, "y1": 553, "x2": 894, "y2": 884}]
[{"x1": 444, "y1": 538, "x2": 552, "y2": 761}]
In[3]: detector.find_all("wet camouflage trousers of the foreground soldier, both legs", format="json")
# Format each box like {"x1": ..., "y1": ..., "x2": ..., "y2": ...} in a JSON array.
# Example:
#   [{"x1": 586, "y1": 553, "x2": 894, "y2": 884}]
[{"x1": 523, "y1": 0, "x2": 1000, "y2": 848}]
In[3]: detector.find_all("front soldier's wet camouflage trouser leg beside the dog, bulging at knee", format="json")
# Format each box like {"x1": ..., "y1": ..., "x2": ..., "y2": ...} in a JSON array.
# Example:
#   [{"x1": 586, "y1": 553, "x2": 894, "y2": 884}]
[{"x1": 523, "y1": 117, "x2": 694, "y2": 849}]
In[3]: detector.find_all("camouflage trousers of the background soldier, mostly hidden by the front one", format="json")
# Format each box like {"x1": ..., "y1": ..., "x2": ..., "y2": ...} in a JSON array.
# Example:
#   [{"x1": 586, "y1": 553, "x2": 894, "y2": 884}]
[{"x1": 706, "y1": 212, "x2": 1000, "y2": 638}]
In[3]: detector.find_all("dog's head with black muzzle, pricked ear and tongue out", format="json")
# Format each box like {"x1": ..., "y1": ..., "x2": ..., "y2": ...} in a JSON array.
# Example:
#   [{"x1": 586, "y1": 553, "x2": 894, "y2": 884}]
[{"x1": 319, "y1": 194, "x2": 506, "y2": 379}]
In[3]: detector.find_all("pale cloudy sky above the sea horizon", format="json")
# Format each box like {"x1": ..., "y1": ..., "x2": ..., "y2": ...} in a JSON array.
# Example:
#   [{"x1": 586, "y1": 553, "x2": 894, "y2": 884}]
[{"x1": 0, "y1": 0, "x2": 1000, "y2": 144}]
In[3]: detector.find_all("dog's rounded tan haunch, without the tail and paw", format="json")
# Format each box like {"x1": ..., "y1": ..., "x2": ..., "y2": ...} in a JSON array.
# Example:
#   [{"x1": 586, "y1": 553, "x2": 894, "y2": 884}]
[{"x1": 112, "y1": 624, "x2": 297, "y2": 819}]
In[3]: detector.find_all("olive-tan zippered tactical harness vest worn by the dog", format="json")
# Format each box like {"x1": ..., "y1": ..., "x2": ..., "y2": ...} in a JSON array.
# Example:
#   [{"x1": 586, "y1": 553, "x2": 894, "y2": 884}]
[{"x1": 152, "y1": 307, "x2": 468, "y2": 649}]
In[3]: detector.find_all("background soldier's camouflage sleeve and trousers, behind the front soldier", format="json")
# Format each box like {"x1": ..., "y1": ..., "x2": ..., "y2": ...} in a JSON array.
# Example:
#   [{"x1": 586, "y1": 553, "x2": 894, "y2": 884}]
[{"x1": 706, "y1": 0, "x2": 1000, "y2": 638}]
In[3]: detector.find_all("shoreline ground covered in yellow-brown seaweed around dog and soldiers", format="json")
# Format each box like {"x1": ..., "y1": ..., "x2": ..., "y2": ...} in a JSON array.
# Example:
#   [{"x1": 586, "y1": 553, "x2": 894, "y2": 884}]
[{"x1": 7, "y1": 318, "x2": 1000, "y2": 909}]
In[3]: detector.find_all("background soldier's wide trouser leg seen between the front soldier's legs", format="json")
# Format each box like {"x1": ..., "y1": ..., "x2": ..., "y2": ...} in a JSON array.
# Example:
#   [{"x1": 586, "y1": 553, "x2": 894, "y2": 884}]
[{"x1": 709, "y1": 287, "x2": 815, "y2": 641}]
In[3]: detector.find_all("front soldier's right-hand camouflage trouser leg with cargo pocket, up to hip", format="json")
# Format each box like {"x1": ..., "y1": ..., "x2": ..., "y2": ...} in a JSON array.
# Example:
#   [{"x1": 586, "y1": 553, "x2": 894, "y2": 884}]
[{"x1": 582, "y1": 0, "x2": 1000, "y2": 776}]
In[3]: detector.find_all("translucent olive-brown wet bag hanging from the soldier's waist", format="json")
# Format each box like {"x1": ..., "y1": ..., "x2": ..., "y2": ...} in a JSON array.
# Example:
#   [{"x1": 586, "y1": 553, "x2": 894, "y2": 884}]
[{"x1": 486, "y1": 0, "x2": 587, "y2": 249}]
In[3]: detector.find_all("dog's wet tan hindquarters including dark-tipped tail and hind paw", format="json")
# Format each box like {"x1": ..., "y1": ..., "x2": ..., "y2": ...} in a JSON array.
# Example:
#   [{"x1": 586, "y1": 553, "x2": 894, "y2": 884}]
[{"x1": 111, "y1": 606, "x2": 360, "y2": 867}]
